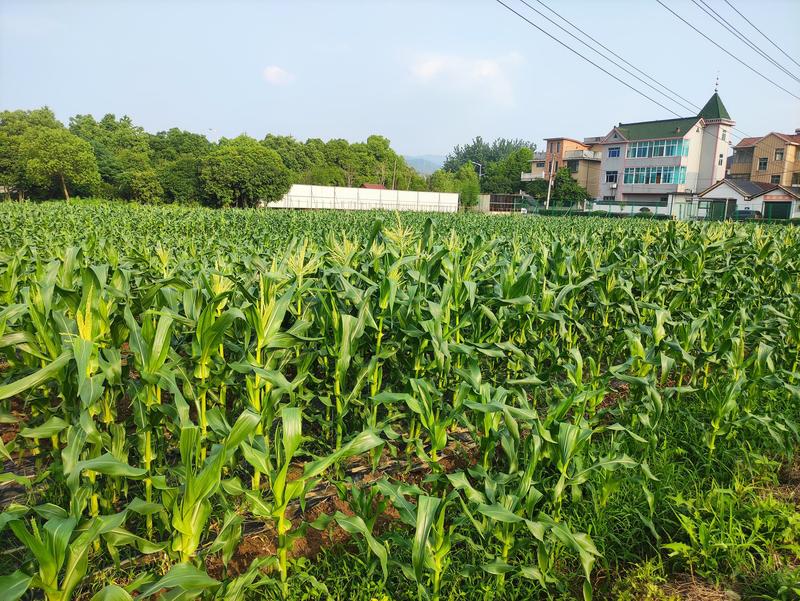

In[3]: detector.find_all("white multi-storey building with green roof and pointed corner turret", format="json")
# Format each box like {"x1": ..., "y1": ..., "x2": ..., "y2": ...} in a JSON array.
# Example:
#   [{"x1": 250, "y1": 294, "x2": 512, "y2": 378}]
[{"x1": 594, "y1": 92, "x2": 735, "y2": 218}]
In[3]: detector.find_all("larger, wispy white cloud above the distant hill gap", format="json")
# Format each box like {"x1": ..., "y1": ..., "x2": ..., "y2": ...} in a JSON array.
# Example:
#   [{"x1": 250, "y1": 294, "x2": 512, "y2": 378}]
[{"x1": 411, "y1": 53, "x2": 522, "y2": 106}]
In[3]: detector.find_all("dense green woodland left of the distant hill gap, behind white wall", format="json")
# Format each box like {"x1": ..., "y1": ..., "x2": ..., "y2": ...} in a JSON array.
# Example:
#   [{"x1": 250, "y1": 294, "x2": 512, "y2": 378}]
[{"x1": 0, "y1": 108, "x2": 428, "y2": 206}]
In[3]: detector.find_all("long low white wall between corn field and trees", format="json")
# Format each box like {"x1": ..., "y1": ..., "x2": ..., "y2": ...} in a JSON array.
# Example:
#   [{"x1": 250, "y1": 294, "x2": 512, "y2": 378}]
[{"x1": 265, "y1": 184, "x2": 458, "y2": 213}]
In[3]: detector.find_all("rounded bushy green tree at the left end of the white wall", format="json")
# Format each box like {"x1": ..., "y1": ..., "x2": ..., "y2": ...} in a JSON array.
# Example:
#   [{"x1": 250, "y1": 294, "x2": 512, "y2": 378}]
[{"x1": 200, "y1": 135, "x2": 291, "y2": 207}]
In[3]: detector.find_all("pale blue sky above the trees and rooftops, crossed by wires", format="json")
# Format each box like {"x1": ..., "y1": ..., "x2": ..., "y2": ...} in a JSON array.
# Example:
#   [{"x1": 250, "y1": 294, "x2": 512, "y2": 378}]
[{"x1": 0, "y1": 0, "x2": 800, "y2": 154}]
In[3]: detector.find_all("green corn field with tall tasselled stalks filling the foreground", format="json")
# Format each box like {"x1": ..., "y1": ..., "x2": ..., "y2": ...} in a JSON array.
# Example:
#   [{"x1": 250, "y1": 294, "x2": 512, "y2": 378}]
[{"x1": 0, "y1": 203, "x2": 800, "y2": 601}]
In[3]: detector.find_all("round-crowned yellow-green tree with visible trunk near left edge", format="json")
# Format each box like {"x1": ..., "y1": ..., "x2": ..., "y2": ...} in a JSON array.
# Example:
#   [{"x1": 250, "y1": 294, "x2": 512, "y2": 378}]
[{"x1": 19, "y1": 127, "x2": 100, "y2": 202}]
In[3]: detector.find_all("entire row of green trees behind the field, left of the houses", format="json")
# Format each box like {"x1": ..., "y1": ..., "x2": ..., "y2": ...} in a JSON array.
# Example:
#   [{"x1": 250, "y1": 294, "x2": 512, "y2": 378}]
[{"x1": 0, "y1": 107, "x2": 586, "y2": 207}]
